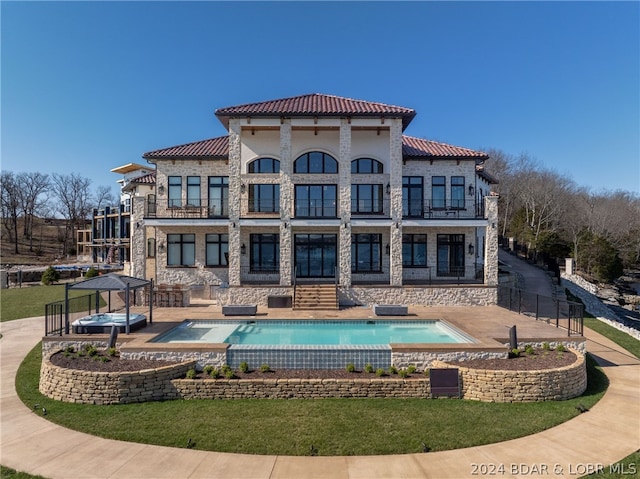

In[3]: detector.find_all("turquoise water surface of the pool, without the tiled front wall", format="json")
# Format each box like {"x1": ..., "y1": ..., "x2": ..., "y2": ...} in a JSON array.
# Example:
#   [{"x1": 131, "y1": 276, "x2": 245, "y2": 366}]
[{"x1": 153, "y1": 320, "x2": 474, "y2": 346}]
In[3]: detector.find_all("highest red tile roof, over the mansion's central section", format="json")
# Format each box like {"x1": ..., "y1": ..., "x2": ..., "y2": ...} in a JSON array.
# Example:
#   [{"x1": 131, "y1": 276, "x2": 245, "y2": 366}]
[{"x1": 215, "y1": 93, "x2": 416, "y2": 128}]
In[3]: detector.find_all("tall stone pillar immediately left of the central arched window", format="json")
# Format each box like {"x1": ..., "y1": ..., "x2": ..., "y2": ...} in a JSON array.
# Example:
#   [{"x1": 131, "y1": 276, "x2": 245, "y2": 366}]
[{"x1": 280, "y1": 118, "x2": 293, "y2": 286}]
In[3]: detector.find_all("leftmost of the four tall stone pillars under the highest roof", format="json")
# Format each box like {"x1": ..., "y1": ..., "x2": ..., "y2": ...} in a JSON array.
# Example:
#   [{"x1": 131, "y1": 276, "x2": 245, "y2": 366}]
[{"x1": 229, "y1": 118, "x2": 242, "y2": 286}]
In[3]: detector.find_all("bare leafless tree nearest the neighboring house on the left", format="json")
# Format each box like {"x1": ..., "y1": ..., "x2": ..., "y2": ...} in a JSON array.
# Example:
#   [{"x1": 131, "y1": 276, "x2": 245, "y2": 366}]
[{"x1": 52, "y1": 173, "x2": 92, "y2": 254}]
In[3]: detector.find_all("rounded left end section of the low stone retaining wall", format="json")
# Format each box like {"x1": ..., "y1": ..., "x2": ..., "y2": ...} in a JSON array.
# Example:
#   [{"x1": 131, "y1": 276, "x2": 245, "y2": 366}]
[{"x1": 39, "y1": 355, "x2": 194, "y2": 404}]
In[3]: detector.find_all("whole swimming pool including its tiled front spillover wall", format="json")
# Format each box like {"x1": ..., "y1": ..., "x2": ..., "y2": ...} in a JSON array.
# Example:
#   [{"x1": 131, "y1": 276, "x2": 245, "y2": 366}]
[{"x1": 151, "y1": 320, "x2": 475, "y2": 369}]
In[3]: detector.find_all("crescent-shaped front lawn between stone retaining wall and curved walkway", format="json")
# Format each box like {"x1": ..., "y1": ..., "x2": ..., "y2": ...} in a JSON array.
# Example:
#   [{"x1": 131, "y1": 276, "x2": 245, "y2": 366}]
[{"x1": 16, "y1": 345, "x2": 608, "y2": 455}]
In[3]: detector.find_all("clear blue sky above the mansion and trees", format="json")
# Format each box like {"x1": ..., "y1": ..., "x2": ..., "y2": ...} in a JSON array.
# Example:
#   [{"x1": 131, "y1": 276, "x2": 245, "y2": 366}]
[{"x1": 0, "y1": 1, "x2": 640, "y2": 193}]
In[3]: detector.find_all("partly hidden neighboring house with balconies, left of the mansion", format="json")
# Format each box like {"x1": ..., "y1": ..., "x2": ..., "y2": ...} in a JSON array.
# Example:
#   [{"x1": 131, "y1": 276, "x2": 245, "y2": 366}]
[{"x1": 90, "y1": 163, "x2": 155, "y2": 274}]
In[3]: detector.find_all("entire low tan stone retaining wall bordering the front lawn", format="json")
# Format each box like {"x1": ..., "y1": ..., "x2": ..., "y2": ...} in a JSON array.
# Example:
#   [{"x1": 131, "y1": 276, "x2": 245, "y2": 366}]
[{"x1": 40, "y1": 353, "x2": 587, "y2": 404}]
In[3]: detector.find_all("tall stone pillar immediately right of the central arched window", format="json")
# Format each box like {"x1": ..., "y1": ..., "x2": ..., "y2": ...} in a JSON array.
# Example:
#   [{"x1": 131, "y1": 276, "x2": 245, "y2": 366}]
[{"x1": 336, "y1": 118, "x2": 351, "y2": 288}]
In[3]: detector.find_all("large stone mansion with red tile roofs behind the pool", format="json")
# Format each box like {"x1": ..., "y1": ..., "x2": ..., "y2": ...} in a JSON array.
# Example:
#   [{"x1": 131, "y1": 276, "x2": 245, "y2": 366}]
[{"x1": 131, "y1": 94, "x2": 498, "y2": 305}]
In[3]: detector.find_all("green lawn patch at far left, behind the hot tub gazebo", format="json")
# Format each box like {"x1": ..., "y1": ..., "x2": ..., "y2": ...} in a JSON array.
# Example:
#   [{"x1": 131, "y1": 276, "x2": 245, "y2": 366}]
[{"x1": 0, "y1": 284, "x2": 106, "y2": 322}]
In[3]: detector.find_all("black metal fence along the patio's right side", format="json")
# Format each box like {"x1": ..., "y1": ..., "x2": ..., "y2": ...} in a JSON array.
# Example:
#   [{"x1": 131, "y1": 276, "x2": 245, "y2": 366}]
[{"x1": 498, "y1": 286, "x2": 584, "y2": 336}]
